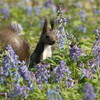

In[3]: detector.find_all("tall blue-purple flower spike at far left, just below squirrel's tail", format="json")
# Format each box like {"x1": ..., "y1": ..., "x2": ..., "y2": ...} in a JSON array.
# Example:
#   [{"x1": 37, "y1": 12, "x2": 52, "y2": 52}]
[{"x1": 2, "y1": 45, "x2": 20, "y2": 77}]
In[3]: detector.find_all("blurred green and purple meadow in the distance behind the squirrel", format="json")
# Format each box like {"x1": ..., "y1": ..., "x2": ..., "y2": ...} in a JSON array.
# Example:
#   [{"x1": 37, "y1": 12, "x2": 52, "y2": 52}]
[{"x1": 0, "y1": 0, "x2": 100, "y2": 48}]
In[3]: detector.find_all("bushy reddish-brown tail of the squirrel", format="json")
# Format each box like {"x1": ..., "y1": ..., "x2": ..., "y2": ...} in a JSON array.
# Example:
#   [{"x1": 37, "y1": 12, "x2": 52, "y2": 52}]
[{"x1": 0, "y1": 25, "x2": 29, "y2": 61}]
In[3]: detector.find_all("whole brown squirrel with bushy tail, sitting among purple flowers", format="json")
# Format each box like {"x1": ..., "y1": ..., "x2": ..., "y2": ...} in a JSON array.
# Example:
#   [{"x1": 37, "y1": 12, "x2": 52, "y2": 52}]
[{"x1": 0, "y1": 18, "x2": 56, "y2": 68}]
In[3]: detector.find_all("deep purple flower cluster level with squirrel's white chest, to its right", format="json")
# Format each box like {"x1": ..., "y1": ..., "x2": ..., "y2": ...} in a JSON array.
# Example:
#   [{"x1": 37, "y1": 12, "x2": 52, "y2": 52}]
[{"x1": 70, "y1": 45, "x2": 83, "y2": 61}]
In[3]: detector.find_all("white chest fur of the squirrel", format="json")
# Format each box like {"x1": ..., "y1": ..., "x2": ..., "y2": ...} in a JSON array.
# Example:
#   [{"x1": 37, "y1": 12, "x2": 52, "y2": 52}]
[{"x1": 42, "y1": 45, "x2": 52, "y2": 59}]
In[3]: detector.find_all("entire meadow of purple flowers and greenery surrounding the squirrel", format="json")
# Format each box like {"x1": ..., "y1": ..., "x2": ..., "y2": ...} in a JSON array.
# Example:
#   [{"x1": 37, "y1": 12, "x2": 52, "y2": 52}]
[{"x1": 0, "y1": 0, "x2": 100, "y2": 100}]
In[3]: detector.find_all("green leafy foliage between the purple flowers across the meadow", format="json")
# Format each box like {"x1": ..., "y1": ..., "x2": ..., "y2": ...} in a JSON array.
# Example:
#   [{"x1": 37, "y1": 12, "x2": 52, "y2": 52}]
[{"x1": 0, "y1": 0, "x2": 100, "y2": 100}]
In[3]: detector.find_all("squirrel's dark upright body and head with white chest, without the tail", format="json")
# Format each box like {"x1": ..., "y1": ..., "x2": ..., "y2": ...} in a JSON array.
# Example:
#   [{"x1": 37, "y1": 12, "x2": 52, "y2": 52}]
[{"x1": 29, "y1": 18, "x2": 56, "y2": 68}]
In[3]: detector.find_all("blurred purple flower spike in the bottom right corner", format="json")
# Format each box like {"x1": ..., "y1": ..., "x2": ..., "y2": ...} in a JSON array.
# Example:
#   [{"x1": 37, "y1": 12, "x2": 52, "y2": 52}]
[{"x1": 83, "y1": 83, "x2": 96, "y2": 100}]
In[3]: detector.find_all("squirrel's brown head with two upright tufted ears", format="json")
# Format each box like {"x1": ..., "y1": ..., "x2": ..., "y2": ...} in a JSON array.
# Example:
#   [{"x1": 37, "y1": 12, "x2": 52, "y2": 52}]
[{"x1": 40, "y1": 18, "x2": 56, "y2": 45}]
